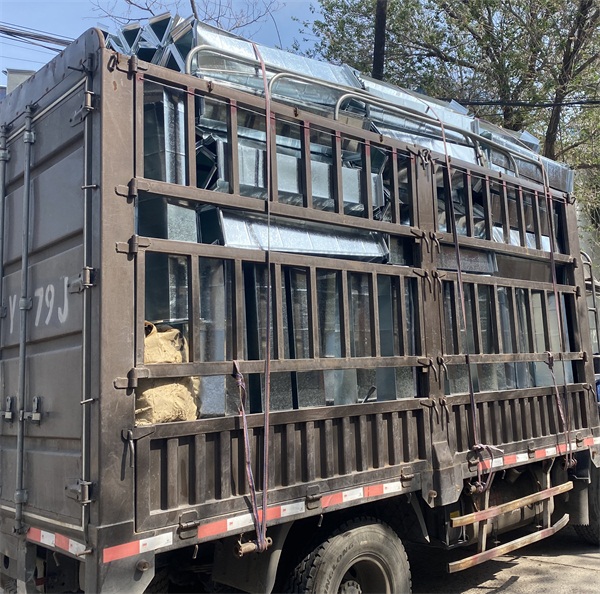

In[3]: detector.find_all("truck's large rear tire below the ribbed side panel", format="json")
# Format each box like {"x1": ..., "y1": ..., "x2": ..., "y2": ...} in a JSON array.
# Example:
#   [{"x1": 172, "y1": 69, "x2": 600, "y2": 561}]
[{"x1": 291, "y1": 518, "x2": 411, "y2": 594}]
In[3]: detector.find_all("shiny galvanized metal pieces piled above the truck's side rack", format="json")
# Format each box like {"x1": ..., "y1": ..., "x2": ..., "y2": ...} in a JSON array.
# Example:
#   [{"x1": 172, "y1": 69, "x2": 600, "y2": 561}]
[{"x1": 107, "y1": 14, "x2": 573, "y2": 191}]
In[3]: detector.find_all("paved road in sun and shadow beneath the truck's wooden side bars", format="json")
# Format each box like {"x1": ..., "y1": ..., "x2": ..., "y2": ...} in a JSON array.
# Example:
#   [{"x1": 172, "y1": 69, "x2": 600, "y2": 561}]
[{"x1": 408, "y1": 527, "x2": 600, "y2": 594}]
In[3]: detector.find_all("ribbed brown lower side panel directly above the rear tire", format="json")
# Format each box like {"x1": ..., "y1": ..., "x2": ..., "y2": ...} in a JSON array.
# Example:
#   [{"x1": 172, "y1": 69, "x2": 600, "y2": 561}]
[{"x1": 132, "y1": 400, "x2": 427, "y2": 531}]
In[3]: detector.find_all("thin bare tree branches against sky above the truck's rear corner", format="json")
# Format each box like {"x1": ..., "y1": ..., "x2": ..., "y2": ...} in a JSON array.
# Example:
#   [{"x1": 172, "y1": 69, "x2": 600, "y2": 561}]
[{"x1": 92, "y1": 0, "x2": 281, "y2": 31}]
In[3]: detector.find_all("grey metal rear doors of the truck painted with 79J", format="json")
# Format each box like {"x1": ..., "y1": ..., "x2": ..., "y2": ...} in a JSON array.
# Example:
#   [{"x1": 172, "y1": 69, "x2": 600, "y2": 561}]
[{"x1": 0, "y1": 83, "x2": 85, "y2": 530}]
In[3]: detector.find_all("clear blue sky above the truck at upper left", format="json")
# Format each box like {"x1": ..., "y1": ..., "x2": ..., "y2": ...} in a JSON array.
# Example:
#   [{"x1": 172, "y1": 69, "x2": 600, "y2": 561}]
[{"x1": 0, "y1": 0, "x2": 311, "y2": 85}]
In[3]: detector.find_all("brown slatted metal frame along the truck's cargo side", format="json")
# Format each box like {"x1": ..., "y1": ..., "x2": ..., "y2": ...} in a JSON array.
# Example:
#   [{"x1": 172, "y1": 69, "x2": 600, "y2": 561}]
[{"x1": 119, "y1": 56, "x2": 593, "y2": 540}]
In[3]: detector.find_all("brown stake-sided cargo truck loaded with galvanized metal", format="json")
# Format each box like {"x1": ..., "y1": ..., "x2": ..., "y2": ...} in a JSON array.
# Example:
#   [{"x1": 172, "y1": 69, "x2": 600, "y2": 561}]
[{"x1": 0, "y1": 20, "x2": 600, "y2": 593}]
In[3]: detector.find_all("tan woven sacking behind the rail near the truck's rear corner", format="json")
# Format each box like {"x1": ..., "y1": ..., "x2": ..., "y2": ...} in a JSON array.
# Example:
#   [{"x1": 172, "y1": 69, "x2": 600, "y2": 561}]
[{"x1": 135, "y1": 322, "x2": 200, "y2": 425}]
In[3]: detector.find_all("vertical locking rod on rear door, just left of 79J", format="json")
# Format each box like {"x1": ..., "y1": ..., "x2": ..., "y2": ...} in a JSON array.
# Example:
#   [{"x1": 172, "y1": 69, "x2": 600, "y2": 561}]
[{"x1": 14, "y1": 105, "x2": 35, "y2": 534}]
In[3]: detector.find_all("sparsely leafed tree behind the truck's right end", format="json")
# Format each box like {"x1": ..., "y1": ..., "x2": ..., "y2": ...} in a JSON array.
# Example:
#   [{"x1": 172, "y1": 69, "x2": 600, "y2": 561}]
[{"x1": 305, "y1": 0, "x2": 600, "y2": 160}]
